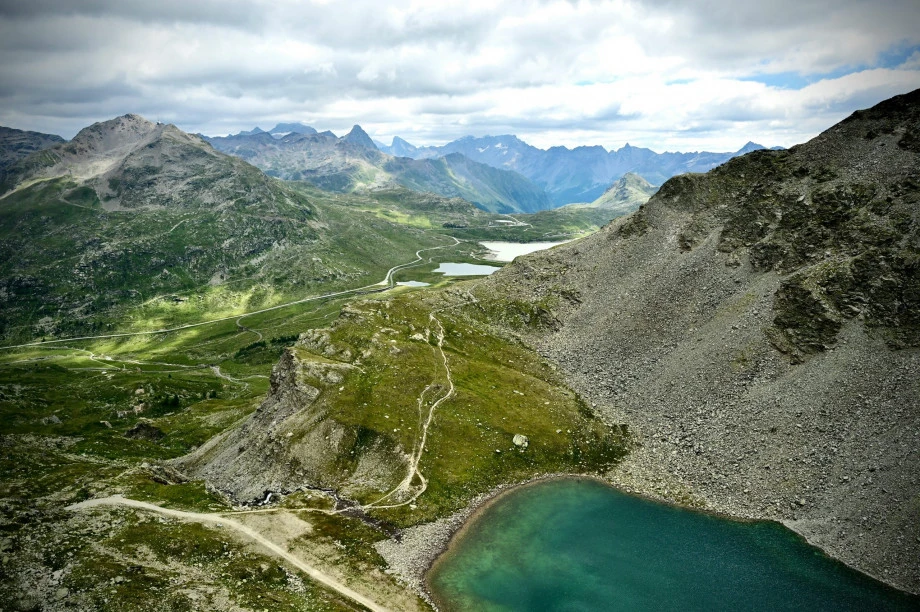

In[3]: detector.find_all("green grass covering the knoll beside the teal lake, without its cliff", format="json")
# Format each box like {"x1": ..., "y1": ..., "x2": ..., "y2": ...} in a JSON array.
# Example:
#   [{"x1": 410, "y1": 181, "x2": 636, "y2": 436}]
[{"x1": 298, "y1": 283, "x2": 628, "y2": 525}]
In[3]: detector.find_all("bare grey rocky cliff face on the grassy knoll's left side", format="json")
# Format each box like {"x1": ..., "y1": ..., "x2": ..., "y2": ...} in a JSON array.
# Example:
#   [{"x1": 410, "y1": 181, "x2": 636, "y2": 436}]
[{"x1": 176, "y1": 346, "x2": 405, "y2": 503}]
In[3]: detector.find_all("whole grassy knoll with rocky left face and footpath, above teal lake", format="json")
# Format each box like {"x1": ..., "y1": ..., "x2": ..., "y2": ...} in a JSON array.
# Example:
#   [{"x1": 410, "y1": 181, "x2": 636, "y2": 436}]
[{"x1": 184, "y1": 282, "x2": 628, "y2": 525}]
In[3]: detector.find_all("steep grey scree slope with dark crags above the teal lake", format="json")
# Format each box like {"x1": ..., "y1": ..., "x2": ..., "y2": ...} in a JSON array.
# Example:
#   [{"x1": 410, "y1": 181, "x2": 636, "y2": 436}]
[{"x1": 478, "y1": 90, "x2": 920, "y2": 593}]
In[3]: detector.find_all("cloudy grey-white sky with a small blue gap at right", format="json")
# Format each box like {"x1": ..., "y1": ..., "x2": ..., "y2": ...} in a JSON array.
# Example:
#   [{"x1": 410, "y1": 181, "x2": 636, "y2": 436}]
[{"x1": 0, "y1": 0, "x2": 920, "y2": 151}]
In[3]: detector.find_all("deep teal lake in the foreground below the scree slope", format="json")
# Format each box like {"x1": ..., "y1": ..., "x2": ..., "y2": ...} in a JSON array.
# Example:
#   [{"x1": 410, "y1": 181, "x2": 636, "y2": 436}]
[{"x1": 429, "y1": 479, "x2": 920, "y2": 612}]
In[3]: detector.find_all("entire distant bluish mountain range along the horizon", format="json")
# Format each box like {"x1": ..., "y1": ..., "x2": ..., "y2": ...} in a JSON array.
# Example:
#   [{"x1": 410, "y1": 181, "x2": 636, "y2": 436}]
[{"x1": 206, "y1": 124, "x2": 764, "y2": 212}]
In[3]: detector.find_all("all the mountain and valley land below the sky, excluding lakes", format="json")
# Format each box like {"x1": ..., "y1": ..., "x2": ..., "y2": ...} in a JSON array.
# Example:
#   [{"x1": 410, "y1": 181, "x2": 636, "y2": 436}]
[{"x1": 0, "y1": 90, "x2": 920, "y2": 610}]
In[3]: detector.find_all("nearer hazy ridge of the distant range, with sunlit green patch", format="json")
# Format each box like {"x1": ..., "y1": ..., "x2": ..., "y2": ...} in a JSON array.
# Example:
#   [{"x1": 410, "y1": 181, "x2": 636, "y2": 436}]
[{"x1": 208, "y1": 125, "x2": 550, "y2": 212}]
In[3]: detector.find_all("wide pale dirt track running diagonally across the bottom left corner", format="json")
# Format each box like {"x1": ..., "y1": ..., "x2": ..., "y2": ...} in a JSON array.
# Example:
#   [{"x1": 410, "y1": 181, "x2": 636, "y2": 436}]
[{"x1": 67, "y1": 495, "x2": 389, "y2": 612}]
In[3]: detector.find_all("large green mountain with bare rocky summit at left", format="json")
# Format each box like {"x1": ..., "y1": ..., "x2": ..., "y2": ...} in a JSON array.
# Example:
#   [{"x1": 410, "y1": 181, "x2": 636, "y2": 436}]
[{"x1": 0, "y1": 115, "x2": 443, "y2": 341}]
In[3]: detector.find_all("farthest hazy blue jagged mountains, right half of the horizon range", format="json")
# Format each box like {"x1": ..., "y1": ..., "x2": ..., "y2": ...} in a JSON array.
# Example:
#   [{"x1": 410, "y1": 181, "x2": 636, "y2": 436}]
[{"x1": 383, "y1": 135, "x2": 763, "y2": 206}]
